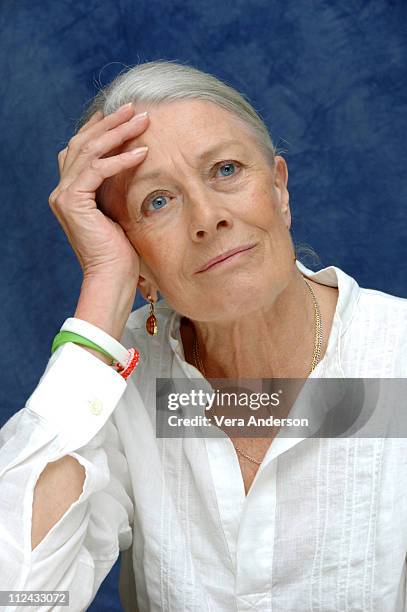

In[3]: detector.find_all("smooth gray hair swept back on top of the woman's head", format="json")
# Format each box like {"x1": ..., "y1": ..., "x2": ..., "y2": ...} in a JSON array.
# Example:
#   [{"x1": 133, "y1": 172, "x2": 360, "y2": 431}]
[{"x1": 76, "y1": 61, "x2": 277, "y2": 165}]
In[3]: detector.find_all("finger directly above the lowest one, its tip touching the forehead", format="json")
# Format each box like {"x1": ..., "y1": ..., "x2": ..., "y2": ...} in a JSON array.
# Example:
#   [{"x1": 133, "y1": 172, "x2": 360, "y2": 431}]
[{"x1": 64, "y1": 114, "x2": 149, "y2": 179}]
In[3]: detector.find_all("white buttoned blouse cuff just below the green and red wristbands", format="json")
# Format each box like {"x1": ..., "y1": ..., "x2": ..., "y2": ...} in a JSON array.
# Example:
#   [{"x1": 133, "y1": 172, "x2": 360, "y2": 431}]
[{"x1": 26, "y1": 342, "x2": 127, "y2": 452}]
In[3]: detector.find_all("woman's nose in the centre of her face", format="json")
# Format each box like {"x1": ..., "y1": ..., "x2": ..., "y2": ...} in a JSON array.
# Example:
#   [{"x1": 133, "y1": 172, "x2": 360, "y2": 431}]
[{"x1": 187, "y1": 189, "x2": 233, "y2": 242}]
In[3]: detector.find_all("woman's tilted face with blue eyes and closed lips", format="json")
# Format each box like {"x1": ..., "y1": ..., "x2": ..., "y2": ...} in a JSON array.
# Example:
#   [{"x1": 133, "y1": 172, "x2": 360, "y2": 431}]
[{"x1": 106, "y1": 100, "x2": 294, "y2": 321}]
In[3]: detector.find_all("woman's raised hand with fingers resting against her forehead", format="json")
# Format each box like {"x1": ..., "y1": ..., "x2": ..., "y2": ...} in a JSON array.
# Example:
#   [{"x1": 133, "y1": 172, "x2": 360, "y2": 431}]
[{"x1": 49, "y1": 104, "x2": 149, "y2": 289}]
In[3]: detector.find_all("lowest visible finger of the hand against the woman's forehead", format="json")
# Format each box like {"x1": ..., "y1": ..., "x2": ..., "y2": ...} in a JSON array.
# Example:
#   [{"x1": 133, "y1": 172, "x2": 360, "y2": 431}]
[{"x1": 62, "y1": 146, "x2": 148, "y2": 193}]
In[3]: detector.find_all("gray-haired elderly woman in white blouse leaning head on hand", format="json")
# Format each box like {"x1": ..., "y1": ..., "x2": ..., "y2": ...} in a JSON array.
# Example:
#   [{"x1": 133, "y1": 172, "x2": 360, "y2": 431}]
[{"x1": 0, "y1": 62, "x2": 407, "y2": 612}]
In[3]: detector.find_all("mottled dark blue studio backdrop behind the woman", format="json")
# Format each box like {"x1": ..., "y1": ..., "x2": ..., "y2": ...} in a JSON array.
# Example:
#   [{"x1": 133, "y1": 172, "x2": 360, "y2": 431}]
[{"x1": 0, "y1": 0, "x2": 407, "y2": 611}]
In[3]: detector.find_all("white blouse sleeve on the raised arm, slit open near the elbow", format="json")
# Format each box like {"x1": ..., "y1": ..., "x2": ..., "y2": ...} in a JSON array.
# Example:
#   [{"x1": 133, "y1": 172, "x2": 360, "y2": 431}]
[{"x1": 0, "y1": 343, "x2": 133, "y2": 612}]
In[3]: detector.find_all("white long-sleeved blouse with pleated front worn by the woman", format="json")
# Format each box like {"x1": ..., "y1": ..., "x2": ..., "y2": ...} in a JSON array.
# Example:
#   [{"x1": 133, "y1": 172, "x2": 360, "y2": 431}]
[{"x1": 0, "y1": 261, "x2": 407, "y2": 612}]
